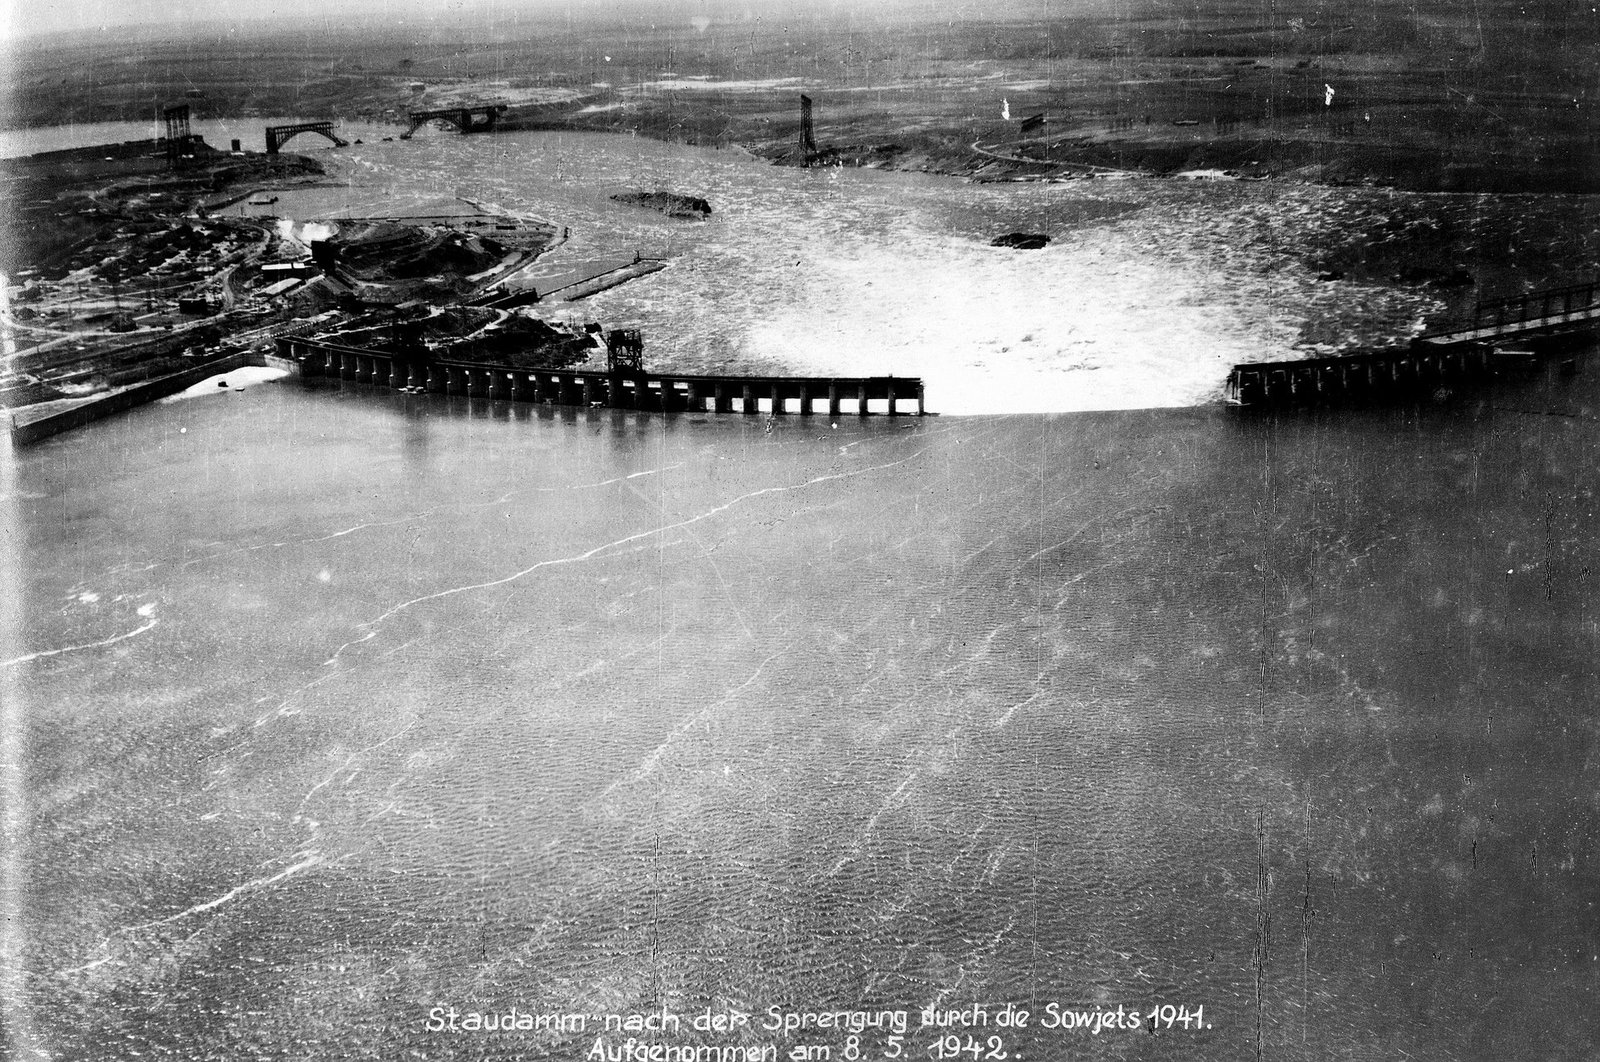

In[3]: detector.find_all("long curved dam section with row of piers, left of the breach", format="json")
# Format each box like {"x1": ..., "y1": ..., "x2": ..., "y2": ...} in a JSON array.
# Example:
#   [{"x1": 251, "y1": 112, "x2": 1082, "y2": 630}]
[{"x1": 277, "y1": 336, "x2": 926, "y2": 417}]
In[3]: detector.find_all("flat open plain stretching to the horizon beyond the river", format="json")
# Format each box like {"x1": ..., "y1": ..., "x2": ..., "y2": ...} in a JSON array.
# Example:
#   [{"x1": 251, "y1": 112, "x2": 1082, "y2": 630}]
[{"x1": 10, "y1": 0, "x2": 1600, "y2": 192}]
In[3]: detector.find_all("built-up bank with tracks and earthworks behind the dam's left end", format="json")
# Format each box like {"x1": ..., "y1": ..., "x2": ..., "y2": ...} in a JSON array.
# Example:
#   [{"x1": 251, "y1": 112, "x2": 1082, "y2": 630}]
[{"x1": 0, "y1": 138, "x2": 555, "y2": 408}]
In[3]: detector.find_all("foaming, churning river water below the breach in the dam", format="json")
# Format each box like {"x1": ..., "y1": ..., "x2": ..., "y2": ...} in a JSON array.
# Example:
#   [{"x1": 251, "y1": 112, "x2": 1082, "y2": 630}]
[{"x1": 312, "y1": 133, "x2": 1430, "y2": 413}]
